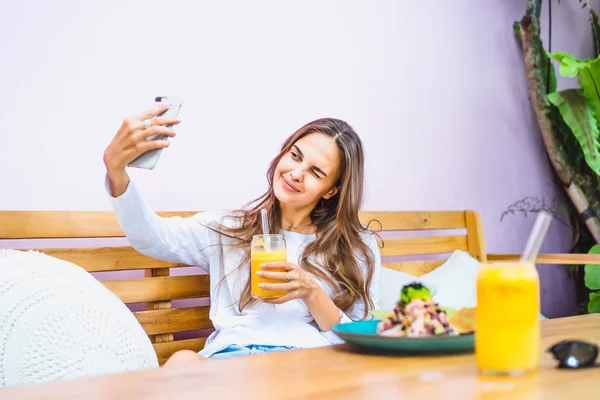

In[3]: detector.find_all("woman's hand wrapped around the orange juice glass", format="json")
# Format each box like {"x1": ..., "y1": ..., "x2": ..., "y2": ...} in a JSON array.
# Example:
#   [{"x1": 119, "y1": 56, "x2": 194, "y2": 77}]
[{"x1": 256, "y1": 262, "x2": 321, "y2": 304}]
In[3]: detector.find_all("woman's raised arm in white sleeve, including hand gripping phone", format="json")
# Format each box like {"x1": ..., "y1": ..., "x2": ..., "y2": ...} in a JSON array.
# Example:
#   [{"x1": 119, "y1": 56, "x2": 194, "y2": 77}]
[{"x1": 104, "y1": 106, "x2": 217, "y2": 271}]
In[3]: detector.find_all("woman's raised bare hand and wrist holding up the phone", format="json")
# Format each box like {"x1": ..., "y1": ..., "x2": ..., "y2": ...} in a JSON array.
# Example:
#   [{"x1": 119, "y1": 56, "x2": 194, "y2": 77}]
[{"x1": 104, "y1": 105, "x2": 180, "y2": 197}]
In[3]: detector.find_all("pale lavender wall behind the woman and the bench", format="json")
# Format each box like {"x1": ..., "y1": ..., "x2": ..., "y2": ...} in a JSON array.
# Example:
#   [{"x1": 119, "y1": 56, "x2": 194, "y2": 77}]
[{"x1": 0, "y1": 0, "x2": 599, "y2": 316}]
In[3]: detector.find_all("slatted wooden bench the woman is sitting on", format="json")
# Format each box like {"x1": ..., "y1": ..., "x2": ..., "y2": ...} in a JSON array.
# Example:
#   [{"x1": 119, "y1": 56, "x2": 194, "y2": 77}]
[{"x1": 0, "y1": 211, "x2": 596, "y2": 364}]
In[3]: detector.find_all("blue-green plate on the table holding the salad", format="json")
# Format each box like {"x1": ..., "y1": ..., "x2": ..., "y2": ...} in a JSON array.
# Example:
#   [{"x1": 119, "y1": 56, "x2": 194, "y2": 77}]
[{"x1": 331, "y1": 320, "x2": 475, "y2": 354}]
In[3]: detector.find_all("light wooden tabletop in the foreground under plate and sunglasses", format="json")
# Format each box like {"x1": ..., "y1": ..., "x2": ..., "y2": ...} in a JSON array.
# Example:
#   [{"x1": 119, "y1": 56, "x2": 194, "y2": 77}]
[{"x1": 0, "y1": 314, "x2": 600, "y2": 400}]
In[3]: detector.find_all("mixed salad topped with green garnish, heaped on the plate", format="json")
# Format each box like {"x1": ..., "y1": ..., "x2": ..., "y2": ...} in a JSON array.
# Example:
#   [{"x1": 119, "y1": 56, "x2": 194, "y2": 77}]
[{"x1": 377, "y1": 282, "x2": 460, "y2": 337}]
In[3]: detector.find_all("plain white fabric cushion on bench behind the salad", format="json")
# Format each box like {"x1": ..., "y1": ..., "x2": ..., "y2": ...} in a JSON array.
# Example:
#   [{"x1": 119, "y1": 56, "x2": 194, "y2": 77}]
[{"x1": 380, "y1": 250, "x2": 480, "y2": 310}]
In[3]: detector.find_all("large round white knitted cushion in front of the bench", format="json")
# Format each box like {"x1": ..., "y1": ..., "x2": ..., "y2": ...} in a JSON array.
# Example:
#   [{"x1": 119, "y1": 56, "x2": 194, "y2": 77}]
[{"x1": 0, "y1": 249, "x2": 158, "y2": 387}]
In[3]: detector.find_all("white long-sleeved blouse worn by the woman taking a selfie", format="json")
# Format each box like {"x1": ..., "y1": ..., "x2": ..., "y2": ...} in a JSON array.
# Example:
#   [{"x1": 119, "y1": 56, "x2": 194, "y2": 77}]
[{"x1": 105, "y1": 177, "x2": 381, "y2": 357}]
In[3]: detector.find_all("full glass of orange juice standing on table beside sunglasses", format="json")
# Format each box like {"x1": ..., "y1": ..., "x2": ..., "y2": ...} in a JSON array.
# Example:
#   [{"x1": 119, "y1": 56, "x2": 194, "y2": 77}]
[{"x1": 475, "y1": 262, "x2": 541, "y2": 375}]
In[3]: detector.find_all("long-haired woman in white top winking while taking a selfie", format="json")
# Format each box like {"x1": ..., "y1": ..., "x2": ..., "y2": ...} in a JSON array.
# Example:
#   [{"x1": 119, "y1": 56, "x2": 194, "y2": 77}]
[{"x1": 104, "y1": 106, "x2": 381, "y2": 361}]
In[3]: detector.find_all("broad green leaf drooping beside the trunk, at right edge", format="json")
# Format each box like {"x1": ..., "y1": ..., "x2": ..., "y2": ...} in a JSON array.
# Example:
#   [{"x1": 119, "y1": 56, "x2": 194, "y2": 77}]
[{"x1": 548, "y1": 89, "x2": 600, "y2": 175}]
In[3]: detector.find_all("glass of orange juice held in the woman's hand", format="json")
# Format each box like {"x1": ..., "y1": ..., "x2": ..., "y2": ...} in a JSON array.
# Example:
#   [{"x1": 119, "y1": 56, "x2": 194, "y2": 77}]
[{"x1": 250, "y1": 234, "x2": 287, "y2": 300}]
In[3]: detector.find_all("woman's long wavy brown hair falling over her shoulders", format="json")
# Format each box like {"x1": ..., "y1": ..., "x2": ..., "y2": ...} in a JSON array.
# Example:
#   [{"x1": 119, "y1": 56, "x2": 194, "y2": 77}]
[{"x1": 219, "y1": 118, "x2": 374, "y2": 318}]
